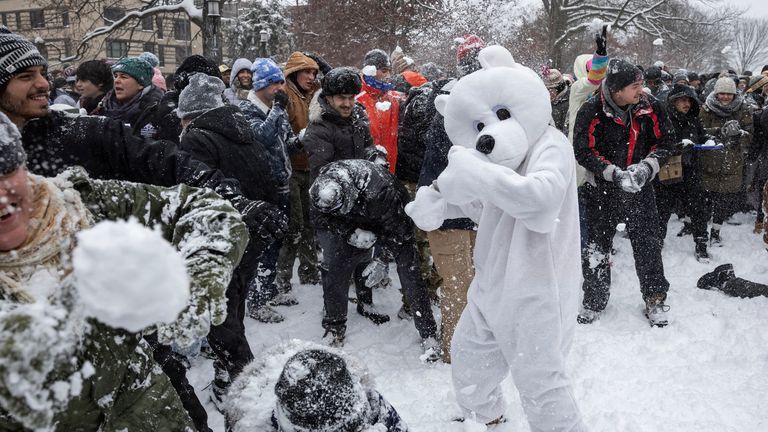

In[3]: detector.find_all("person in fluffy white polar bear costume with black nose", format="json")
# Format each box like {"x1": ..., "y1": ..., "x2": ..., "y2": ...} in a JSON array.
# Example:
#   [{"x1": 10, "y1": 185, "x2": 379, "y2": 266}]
[{"x1": 406, "y1": 46, "x2": 586, "y2": 432}]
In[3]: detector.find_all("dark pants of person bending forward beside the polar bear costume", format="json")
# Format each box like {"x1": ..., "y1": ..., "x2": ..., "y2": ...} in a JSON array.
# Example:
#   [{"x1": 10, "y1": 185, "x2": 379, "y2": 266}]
[{"x1": 316, "y1": 229, "x2": 437, "y2": 338}]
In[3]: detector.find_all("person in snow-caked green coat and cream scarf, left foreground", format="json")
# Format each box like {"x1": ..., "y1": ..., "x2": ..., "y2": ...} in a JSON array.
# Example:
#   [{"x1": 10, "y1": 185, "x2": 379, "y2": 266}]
[{"x1": 0, "y1": 114, "x2": 248, "y2": 432}]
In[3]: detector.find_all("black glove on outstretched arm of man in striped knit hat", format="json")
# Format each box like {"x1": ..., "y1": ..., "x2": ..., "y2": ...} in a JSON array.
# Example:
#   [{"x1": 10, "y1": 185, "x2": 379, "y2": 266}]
[{"x1": 230, "y1": 196, "x2": 288, "y2": 252}]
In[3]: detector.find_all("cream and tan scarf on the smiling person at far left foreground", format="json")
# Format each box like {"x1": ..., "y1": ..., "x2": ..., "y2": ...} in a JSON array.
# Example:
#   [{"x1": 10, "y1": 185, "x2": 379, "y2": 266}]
[{"x1": 0, "y1": 175, "x2": 92, "y2": 303}]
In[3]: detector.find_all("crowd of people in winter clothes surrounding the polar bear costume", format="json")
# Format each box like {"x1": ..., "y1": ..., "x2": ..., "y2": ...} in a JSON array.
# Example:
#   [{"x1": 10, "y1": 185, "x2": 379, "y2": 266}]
[{"x1": 0, "y1": 20, "x2": 768, "y2": 432}]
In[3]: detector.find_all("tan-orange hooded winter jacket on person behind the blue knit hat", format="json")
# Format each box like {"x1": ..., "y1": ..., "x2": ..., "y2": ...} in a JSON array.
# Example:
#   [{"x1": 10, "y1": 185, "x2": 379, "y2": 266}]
[{"x1": 283, "y1": 52, "x2": 320, "y2": 172}]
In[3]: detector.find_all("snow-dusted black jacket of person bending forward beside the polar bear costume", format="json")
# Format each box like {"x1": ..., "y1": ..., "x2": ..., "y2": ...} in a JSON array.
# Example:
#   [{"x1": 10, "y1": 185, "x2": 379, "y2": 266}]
[{"x1": 310, "y1": 160, "x2": 414, "y2": 251}]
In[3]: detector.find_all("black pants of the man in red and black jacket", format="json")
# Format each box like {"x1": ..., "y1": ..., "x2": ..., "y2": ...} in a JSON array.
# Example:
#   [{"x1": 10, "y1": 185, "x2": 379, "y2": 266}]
[{"x1": 582, "y1": 182, "x2": 669, "y2": 311}]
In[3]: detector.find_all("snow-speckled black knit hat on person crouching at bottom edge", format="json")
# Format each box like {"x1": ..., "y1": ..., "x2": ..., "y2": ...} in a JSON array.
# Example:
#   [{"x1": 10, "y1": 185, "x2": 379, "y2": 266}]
[{"x1": 275, "y1": 349, "x2": 362, "y2": 431}]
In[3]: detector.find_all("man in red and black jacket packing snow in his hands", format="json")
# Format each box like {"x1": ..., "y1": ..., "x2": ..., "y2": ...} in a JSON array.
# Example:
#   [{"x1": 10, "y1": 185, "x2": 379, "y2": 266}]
[{"x1": 573, "y1": 60, "x2": 674, "y2": 326}]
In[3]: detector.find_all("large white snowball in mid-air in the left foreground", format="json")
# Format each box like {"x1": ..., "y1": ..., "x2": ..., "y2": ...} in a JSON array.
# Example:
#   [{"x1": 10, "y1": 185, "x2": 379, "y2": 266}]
[{"x1": 72, "y1": 219, "x2": 190, "y2": 332}]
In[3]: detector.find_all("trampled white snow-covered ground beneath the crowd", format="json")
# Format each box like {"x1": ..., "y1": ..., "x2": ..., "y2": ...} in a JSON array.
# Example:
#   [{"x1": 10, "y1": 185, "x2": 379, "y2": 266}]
[{"x1": 190, "y1": 214, "x2": 768, "y2": 432}]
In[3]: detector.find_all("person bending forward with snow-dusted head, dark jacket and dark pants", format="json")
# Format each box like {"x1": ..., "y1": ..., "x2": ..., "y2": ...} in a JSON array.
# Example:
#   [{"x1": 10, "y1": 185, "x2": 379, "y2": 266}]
[{"x1": 309, "y1": 160, "x2": 440, "y2": 361}]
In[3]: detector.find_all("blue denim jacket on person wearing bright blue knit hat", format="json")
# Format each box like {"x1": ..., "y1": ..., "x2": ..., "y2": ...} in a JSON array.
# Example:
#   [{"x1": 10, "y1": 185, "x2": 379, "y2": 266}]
[{"x1": 240, "y1": 91, "x2": 301, "y2": 190}]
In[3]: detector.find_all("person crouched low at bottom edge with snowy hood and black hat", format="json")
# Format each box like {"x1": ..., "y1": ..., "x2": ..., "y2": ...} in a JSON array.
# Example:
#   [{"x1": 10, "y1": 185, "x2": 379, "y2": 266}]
[{"x1": 225, "y1": 340, "x2": 408, "y2": 432}]
